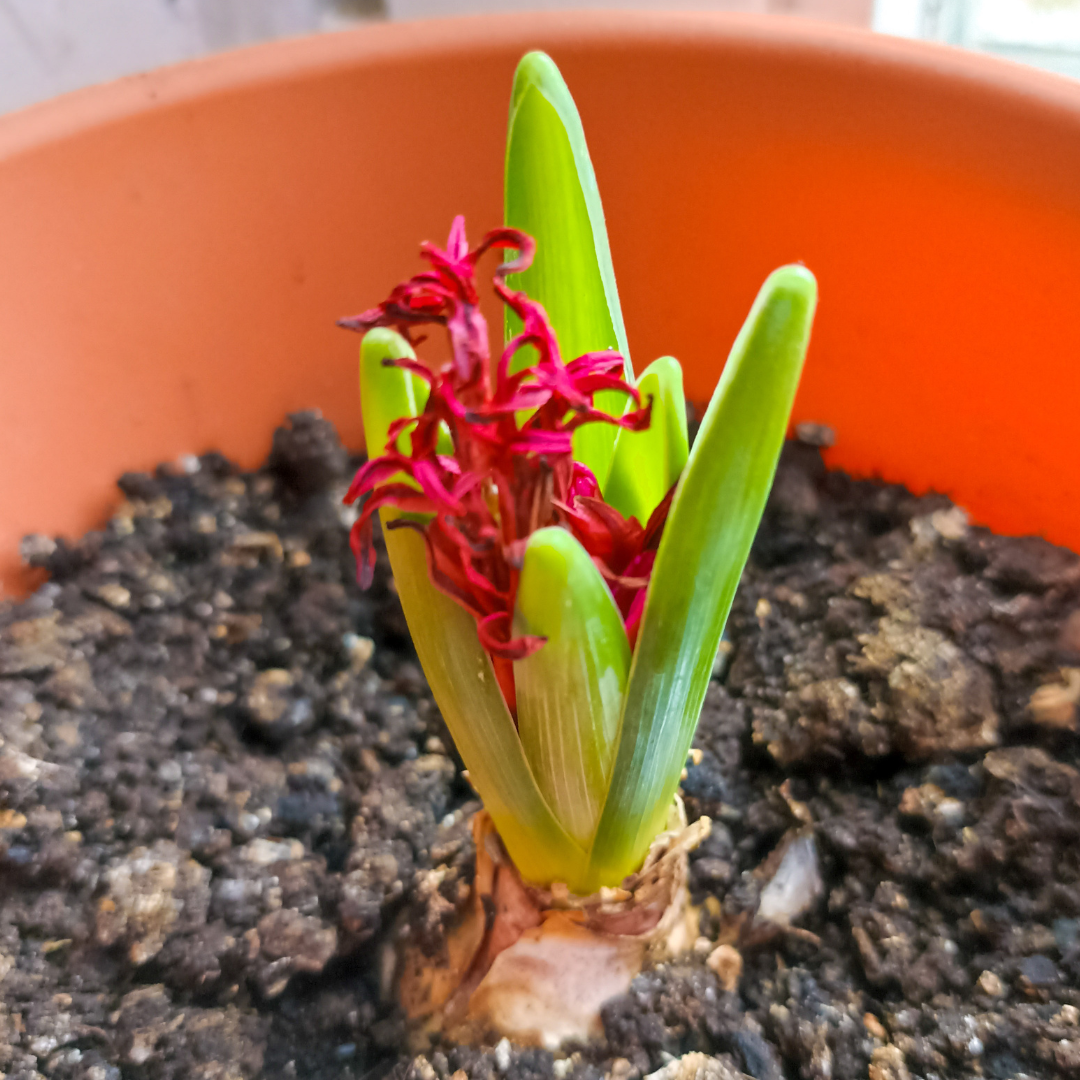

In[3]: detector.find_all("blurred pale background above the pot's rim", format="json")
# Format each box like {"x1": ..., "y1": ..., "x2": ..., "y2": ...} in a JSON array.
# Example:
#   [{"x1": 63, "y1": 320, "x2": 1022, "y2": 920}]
[{"x1": 0, "y1": 0, "x2": 1080, "y2": 112}]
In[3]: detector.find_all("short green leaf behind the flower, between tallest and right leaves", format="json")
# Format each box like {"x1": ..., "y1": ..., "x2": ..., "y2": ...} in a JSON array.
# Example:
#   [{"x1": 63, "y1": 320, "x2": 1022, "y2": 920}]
[{"x1": 604, "y1": 356, "x2": 690, "y2": 525}]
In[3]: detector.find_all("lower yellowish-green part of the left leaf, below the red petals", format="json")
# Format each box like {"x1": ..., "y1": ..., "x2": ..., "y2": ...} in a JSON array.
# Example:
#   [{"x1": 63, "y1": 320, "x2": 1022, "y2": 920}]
[{"x1": 383, "y1": 517, "x2": 585, "y2": 888}]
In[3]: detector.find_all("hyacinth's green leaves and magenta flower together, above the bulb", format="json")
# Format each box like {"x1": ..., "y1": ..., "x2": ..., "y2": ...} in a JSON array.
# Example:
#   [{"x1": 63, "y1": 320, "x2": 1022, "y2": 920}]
[{"x1": 342, "y1": 53, "x2": 816, "y2": 895}]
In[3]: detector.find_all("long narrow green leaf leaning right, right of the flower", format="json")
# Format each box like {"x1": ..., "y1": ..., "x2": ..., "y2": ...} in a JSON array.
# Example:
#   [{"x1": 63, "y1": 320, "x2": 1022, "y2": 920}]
[{"x1": 589, "y1": 266, "x2": 818, "y2": 887}]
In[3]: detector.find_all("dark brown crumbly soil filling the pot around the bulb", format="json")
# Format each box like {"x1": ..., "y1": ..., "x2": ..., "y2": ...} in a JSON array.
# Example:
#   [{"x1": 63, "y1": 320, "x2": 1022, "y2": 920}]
[{"x1": 0, "y1": 415, "x2": 1080, "y2": 1080}]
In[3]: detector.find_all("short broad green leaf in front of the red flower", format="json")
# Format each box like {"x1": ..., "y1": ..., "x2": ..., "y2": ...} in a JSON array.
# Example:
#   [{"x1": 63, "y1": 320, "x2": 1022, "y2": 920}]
[{"x1": 514, "y1": 527, "x2": 630, "y2": 847}]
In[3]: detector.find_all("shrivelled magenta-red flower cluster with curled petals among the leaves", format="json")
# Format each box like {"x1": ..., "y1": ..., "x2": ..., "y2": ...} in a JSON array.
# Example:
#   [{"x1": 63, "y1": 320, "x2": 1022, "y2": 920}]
[{"x1": 342, "y1": 217, "x2": 671, "y2": 713}]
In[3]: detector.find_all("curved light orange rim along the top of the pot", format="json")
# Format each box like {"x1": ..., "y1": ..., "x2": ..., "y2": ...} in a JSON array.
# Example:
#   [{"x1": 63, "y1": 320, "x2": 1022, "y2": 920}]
[{"x1": 0, "y1": 8, "x2": 1080, "y2": 150}]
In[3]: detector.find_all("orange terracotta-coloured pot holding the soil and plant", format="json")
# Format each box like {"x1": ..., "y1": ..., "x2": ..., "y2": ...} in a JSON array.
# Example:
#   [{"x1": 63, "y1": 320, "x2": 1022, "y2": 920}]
[{"x1": 0, "y1": 13, "x2": 1080, "y2": 589}]
